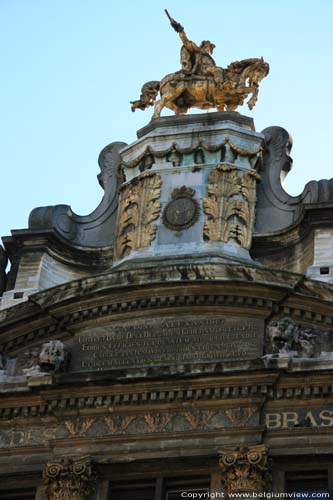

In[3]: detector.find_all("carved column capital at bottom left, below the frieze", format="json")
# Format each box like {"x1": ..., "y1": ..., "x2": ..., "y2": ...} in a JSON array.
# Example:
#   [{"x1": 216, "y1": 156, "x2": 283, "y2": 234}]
[{"x1": 43, "y1": 457, "x2": 94, "y2": 500}]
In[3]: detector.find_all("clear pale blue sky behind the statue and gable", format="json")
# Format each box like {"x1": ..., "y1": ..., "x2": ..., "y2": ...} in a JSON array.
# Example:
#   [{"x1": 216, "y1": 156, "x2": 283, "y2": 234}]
[{"x1": 0, "y1": 0, "x2": 333, "y2": 242}]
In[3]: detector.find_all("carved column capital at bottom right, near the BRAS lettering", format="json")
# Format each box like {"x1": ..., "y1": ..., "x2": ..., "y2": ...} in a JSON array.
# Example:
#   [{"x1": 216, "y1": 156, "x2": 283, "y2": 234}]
[{"x1": 219, "y1": 445, "x2": 271, "y2": 495}]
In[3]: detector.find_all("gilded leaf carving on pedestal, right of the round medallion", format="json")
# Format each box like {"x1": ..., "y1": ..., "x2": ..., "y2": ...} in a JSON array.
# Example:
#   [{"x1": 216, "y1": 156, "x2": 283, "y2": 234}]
[{"x1": 203, "y1": 164, "x2": 258, "y2": 249}]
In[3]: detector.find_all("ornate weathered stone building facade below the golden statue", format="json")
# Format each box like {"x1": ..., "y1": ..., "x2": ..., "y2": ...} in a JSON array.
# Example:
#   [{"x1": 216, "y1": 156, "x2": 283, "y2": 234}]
[{"x1": 0, "y1": 113, "x2": 333, "y2": 494}]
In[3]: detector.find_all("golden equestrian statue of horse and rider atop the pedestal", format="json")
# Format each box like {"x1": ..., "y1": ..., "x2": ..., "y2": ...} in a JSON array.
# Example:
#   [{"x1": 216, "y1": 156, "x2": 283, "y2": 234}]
[{"x1": 131, "y1": 10, "x2": 269, "y2": 119}]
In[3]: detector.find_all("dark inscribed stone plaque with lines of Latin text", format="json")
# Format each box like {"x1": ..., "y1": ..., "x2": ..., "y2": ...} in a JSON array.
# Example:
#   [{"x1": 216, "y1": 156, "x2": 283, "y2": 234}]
[{"x1": 71, "y1": 316, "x2": 264, "y2": 371}]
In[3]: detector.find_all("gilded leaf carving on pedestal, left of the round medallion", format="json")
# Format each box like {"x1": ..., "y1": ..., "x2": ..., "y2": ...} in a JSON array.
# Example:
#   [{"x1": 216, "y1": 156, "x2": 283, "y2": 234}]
[{"x1": 115, "y1": 172, "x2": 161, "y2": 259}]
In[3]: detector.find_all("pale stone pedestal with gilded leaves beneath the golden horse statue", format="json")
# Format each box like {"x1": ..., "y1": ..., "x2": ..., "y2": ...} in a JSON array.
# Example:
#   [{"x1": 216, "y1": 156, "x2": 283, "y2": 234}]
[{"x1": 114, "y1": 113, "x2": 264, "y2": 268}]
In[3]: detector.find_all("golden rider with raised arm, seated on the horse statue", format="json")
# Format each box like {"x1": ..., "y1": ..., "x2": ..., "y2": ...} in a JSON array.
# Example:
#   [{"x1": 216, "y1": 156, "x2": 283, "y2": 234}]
[{"x1": 167, "y1": 12, "x2": 223, "y2": 86}]
